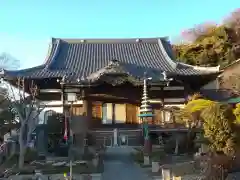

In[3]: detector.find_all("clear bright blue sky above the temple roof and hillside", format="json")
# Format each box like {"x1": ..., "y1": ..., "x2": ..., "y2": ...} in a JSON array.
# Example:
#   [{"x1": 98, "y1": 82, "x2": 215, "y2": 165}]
[{"x1": 0, "y1": 0, "x2": 240, "y2": 68}]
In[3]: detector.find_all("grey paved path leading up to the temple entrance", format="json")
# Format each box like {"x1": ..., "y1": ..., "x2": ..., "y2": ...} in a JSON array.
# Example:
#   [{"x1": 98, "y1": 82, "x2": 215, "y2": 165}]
[{"x1": 103, "y1": 147, "x2": 151, "y2": 180}]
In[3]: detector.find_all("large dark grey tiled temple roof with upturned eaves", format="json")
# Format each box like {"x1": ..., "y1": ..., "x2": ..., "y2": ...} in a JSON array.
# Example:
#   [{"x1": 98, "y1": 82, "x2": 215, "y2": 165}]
[{"x1": 2, "y1": 38, "x2": 219, "y2": 83}]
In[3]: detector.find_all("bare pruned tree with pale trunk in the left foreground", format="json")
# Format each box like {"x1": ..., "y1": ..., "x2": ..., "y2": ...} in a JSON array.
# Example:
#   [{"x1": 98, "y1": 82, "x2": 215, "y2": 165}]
[{"x1": 2, "y1": 78, "x2": 44, "y2": 168}]
